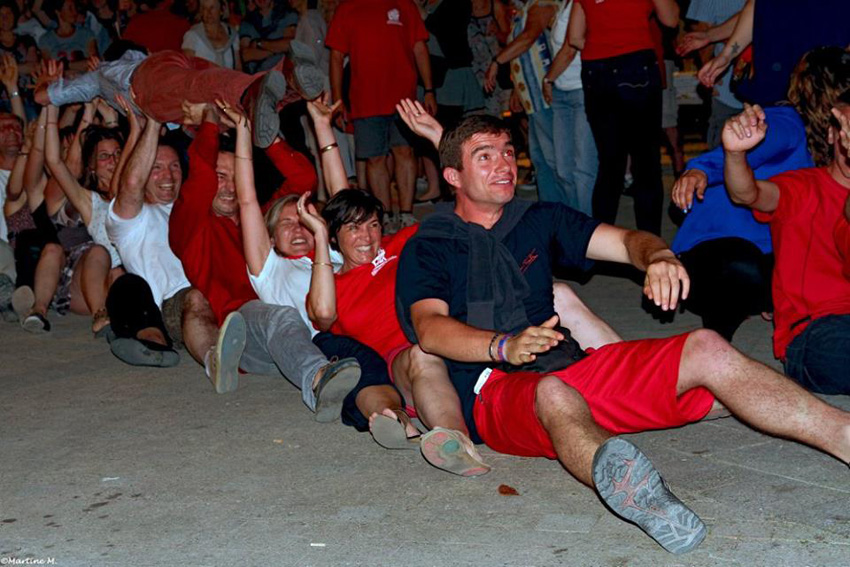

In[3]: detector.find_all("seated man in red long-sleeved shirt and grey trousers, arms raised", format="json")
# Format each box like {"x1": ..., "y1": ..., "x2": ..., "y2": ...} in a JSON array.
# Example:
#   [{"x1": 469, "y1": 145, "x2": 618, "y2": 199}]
[{"x1": 169, "y1": 100, "x2": 359, "y2": 421}]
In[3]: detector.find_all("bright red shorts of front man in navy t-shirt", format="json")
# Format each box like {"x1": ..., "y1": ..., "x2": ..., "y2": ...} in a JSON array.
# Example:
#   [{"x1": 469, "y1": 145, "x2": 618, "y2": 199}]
[{"x1": 473, "y1": 334, "x2": 714, "y2": 459}]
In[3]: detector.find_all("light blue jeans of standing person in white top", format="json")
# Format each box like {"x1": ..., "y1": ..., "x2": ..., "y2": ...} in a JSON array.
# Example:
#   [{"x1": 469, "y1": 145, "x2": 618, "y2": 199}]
[{"x1": 552, "y1": 89, "x2": 599, "y2": 215}]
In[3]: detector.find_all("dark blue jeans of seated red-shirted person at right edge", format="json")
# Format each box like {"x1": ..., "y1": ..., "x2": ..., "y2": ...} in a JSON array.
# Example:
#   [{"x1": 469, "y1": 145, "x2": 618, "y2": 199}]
[{"x1": 785, "y1": 315, "x2": 850, "y2": 394}]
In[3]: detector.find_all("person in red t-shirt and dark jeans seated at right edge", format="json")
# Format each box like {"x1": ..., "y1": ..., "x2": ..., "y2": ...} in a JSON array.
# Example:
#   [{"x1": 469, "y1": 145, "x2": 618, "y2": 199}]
[{"x1": 722, "y1": 97, "x2": 850, "y2": 394}]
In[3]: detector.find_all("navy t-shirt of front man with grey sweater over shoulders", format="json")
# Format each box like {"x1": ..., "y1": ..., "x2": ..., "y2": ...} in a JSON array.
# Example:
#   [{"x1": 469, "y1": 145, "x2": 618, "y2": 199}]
[{"x1": 396, "y1": 203, "x2": 600, "y2": 443}]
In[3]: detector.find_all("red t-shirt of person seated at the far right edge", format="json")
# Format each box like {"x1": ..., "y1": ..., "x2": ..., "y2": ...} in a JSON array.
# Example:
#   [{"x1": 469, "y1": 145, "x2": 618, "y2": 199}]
[{"x1": 753, "y1": 168, "x2": 850, "y2": 360}]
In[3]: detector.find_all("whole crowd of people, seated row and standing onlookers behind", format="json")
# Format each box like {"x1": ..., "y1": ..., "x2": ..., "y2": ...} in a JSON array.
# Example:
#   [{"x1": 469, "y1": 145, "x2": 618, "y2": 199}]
[{"x1": 0, "y1": 0, "x2": 850, "y2": 553}]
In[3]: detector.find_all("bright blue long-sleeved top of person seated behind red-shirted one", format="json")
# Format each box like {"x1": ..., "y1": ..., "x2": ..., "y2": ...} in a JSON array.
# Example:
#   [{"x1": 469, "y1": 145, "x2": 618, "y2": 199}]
[{"x1": 671, "y1": 106, "x2": 814, "y2": 254}]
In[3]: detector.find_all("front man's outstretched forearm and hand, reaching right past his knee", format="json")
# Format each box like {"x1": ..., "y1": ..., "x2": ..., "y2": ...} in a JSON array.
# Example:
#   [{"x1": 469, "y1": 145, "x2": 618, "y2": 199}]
[{"x1": 587, "y1": 224, "x2": 691, "y2": 311}]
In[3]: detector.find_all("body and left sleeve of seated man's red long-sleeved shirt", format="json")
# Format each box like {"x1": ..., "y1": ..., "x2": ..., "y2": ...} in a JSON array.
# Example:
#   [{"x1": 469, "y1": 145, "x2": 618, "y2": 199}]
[{"x1": 168, "y1": 122, "x2": 257, "y2": 325}]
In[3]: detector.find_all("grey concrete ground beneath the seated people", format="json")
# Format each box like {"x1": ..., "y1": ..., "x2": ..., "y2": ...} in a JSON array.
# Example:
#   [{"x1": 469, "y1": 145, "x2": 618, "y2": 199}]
[{"x1": 0, "y1": 191, "x2": 850, "y2": 567}]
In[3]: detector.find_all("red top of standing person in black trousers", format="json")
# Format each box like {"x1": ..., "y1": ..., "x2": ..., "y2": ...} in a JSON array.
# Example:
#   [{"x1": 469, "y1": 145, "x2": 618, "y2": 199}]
[{"x1": 576, "y1": 0, "x2": 654, "y2": 61}]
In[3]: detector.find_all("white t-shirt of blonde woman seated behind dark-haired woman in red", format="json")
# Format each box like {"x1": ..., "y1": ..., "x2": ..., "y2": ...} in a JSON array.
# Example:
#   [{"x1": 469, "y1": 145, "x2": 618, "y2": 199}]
[{"x1": 248, "y1": 250, "x2": 342, "y2": 337}]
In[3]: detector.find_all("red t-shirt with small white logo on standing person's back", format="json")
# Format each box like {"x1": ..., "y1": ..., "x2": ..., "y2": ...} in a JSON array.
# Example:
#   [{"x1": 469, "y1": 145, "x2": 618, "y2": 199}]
[{"x1": 325, "y1": 0, "x2": 428, "y2": 118}]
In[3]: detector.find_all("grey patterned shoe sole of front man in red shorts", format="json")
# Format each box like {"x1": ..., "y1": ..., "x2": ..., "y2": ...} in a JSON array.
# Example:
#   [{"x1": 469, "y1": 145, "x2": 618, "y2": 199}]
[{"x1": 593, "y1": 437, "x2": 707, "y2": 555}]
